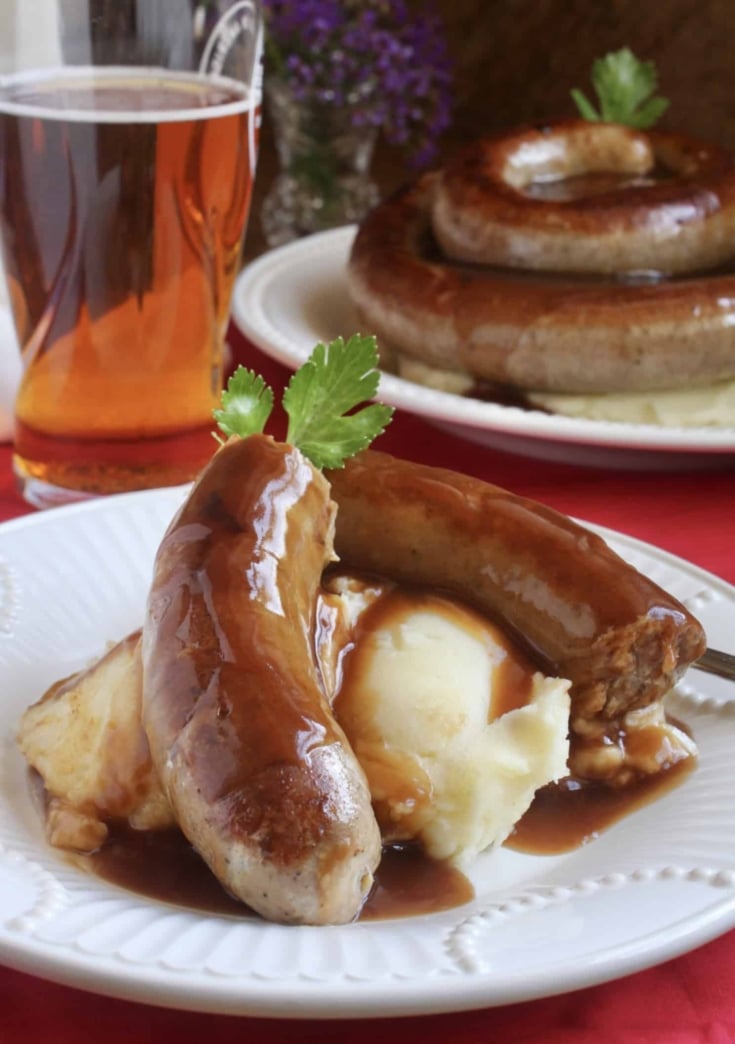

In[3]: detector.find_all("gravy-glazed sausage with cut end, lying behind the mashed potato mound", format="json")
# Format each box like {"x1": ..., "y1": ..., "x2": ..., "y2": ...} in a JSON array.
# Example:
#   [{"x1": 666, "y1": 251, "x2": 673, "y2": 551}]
[{"x1": 328, "y1": 451, "x2": 706, "y2": 736}]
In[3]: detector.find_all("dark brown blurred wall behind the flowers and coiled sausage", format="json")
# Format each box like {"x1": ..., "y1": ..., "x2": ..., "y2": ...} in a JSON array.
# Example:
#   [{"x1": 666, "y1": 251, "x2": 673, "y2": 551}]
[{"x1": 245, "y1": 0, "x2": 735, "y2": 257}]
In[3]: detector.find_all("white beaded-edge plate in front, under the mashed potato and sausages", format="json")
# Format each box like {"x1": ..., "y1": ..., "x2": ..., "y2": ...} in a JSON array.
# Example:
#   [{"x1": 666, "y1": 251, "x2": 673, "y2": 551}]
[{"x1": 0, "y1": 489, "x2": 735, "y2": 1018}]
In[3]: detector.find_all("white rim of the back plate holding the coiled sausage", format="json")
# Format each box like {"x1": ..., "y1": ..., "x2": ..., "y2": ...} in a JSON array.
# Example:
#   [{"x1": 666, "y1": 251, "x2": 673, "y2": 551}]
[{"x1": 232, "y1": 224, "x2": 735, "y2": 456}]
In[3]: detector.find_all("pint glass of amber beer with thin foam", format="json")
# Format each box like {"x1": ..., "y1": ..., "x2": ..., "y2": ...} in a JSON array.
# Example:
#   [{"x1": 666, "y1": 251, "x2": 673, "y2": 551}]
[{"x1": 0, "y1": 0, "x2": 262, "y2": 506}]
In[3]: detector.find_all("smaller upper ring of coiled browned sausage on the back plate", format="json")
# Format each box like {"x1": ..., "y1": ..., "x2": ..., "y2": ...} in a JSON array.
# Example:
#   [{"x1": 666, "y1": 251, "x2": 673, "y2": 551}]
[{"x1": 432, "y1": 120, "x2": 735, "y2": 275}]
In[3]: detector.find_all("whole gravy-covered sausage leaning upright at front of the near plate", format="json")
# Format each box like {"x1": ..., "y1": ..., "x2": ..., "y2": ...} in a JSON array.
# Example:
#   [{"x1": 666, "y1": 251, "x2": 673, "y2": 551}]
[{"x1": 143, "y1": 435, "x2": 381, "y2": 924}]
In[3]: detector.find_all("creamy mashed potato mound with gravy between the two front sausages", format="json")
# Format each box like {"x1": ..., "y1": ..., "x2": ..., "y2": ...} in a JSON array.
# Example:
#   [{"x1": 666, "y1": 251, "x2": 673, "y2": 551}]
[{"x1": 334, "y1": 593, "x2": 570, "y2": 868}]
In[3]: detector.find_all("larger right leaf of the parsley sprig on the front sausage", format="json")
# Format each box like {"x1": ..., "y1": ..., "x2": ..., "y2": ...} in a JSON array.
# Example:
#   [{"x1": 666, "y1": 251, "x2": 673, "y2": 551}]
[{"x1": 283, "y1": 334, "x2": 393, "y2": 468}]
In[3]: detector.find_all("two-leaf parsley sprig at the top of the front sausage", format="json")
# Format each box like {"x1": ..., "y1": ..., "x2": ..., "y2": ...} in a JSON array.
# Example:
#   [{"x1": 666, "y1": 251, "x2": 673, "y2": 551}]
[{"x1": 213, "y1": 334, "x2": 394, "y2": 468}]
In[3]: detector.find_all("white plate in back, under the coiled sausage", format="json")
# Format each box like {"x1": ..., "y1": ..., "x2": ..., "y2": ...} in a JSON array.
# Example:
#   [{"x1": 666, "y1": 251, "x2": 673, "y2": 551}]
[{"x1": 233, "y1": 227, "x2": 735, "y2": 469}]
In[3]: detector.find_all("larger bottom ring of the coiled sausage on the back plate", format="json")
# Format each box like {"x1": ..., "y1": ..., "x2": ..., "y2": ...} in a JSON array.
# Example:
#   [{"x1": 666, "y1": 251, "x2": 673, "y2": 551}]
[{"x1": 347, "y1": 172, "x2": 735, "y2": 393}]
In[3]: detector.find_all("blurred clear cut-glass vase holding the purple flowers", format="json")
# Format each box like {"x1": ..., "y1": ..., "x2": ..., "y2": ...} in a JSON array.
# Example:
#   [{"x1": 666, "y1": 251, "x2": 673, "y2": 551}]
[{"x1": 261, "y1": 79, "x2": 379, "y2": 246}]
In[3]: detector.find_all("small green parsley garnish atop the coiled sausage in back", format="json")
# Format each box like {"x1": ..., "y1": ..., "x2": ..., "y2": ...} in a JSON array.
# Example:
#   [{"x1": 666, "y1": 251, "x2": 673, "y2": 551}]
[{"x1": 571, "y1": 47, "x2": 668, "y2": 131}]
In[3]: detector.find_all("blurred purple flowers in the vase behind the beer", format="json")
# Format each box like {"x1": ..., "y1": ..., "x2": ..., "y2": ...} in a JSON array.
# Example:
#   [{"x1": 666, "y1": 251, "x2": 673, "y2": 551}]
[{"x1": 258, "y1": 0, "x2": 451, "y2": 167}]
